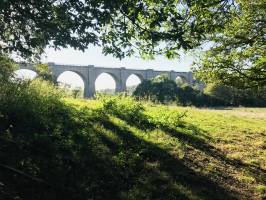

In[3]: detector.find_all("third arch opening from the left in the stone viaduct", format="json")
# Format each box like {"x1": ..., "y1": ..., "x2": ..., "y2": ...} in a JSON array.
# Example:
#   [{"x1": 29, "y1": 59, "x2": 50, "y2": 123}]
[{"x1": 95, "y1": 72, "x2": 117, "y2": 95}]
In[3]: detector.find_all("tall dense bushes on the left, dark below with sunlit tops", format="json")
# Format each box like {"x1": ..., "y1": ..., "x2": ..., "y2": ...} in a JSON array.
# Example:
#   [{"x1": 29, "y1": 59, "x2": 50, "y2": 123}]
[{"x1": 0, "y1": 55, "x2": 87, "y2": 199}]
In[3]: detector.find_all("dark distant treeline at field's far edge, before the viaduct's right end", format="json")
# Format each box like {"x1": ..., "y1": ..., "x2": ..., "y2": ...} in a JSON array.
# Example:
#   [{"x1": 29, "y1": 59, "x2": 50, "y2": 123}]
[{"x1": 133, "y1": 76, "x2": 266, "y2": 107}]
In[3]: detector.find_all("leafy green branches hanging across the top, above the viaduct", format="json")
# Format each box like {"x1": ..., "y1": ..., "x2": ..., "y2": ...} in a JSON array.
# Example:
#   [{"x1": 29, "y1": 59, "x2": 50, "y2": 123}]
[{"x1": 0, "y1": 0, "x2": 232, "y2": 58}]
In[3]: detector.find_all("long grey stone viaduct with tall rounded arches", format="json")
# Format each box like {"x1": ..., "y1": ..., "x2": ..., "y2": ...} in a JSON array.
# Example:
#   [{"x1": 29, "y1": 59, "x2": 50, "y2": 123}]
[{"x1": 19, "y1": 63, "x2": 194, "y2": 98}]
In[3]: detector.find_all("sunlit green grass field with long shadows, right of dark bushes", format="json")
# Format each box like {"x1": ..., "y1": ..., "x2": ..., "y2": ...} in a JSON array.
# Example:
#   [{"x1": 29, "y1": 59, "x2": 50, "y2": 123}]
[{"x1": 62, "y1": 99, "x2": 266, "y2": 199}]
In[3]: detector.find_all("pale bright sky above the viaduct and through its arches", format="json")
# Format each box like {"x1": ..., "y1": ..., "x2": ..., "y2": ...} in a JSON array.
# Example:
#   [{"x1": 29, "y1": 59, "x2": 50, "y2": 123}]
[{"x1": 15, "y1": 46, "x2": 194, "y2": 90}]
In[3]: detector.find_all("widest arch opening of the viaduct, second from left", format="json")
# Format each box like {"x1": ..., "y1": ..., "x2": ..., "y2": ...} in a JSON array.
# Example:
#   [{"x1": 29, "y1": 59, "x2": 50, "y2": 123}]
[{"x1": 57, "y1": 71, "x2": 85, "y2": 98}]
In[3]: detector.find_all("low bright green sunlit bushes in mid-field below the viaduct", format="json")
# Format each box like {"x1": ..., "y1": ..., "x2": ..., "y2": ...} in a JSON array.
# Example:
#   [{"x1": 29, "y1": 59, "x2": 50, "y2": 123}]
[{"x1": 97, "y1": 95, "x2": 186, "y2": 129}]
